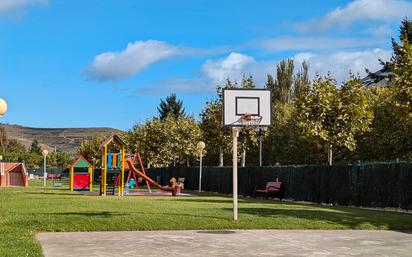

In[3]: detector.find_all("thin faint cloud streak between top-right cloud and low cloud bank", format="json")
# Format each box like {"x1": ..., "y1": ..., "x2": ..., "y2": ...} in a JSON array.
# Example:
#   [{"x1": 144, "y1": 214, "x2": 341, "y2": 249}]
[{"x1": 254, "y1": 36, "x2": 387, "y2": 52}]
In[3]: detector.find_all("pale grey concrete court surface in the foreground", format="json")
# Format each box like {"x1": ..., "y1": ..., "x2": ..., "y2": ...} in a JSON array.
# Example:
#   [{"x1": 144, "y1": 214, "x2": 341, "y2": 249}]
[{"x1": 37, "y1": 230, "x2": 412, "y2": 257}]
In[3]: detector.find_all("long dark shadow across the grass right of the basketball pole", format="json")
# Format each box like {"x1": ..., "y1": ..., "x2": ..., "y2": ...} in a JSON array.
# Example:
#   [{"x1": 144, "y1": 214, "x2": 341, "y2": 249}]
[{"x1": 232, "y1": 208, "x2": 412, "y2": 228}]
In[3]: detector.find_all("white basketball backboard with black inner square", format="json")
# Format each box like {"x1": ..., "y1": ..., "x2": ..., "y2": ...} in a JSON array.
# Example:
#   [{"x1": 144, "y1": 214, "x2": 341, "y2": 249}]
[{"x1": 223, "y1": 88, "x2": 272, "y2": 127}]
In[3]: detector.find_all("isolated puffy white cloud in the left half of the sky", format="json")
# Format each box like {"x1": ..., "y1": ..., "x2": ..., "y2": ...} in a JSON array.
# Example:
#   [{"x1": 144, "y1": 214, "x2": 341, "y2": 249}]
[{"x1": 85, "y1": 40, "x2": 179, "y2": 80}]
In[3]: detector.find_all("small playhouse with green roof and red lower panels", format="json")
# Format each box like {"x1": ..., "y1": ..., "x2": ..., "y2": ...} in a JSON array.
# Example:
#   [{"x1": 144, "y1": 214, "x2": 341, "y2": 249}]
[{"x1": 70, "y1": 155, "x2": 94, "y2": 191}]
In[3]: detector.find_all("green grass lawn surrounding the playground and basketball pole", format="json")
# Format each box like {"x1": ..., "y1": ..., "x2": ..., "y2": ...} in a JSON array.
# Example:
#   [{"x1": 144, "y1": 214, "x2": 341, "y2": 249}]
[{"x1": 0, "y1": 181, "x2": 412, "y2": 256}]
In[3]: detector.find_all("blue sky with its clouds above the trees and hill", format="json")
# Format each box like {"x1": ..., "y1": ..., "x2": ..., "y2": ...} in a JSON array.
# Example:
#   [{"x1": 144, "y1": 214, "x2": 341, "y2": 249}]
[{"x1": 0, "y1": 0, "x2": 412, "y2": 129}]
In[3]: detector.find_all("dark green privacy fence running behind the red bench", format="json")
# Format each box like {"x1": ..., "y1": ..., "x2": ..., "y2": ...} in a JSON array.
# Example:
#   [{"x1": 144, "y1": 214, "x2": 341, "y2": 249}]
[{"x1": 148, "y1": 162, "x2": 412, "y2": 209}]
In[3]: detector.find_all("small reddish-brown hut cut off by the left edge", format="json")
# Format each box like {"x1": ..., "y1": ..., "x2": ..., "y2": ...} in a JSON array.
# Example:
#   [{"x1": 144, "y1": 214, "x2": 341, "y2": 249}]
[{"x1": 0, "y1": 162, "x2": 29, "y2": 187}]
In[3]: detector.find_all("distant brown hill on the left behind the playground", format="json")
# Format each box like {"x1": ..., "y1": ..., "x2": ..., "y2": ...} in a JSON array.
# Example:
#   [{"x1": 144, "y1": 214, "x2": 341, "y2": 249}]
[{"x1": 1, "y1": 124, "x2": 119, "y2": 153}]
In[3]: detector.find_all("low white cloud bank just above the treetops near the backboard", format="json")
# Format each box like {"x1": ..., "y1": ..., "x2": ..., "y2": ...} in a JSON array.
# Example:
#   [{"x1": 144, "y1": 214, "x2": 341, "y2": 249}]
[{"x1": 138, "y1": 48, "x2": 392, "y2": 95}]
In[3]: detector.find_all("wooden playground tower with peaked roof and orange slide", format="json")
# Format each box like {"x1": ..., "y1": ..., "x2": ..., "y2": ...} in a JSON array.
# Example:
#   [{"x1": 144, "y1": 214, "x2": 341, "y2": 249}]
[{"x1": 100, "y1": 134, "x2": 183, "y2": 196}]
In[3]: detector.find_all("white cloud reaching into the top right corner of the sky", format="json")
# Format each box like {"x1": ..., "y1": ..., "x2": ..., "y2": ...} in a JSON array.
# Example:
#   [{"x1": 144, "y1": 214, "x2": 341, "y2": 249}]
[{"x1": 296, "y1": 0, "x2": 412, "y2": 31}]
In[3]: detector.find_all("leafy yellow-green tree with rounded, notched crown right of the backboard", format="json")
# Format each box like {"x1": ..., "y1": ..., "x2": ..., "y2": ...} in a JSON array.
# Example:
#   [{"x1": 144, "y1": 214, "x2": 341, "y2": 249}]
[{"x1": 297, "y1": 76, "x2": 373, "y2": 165}]
